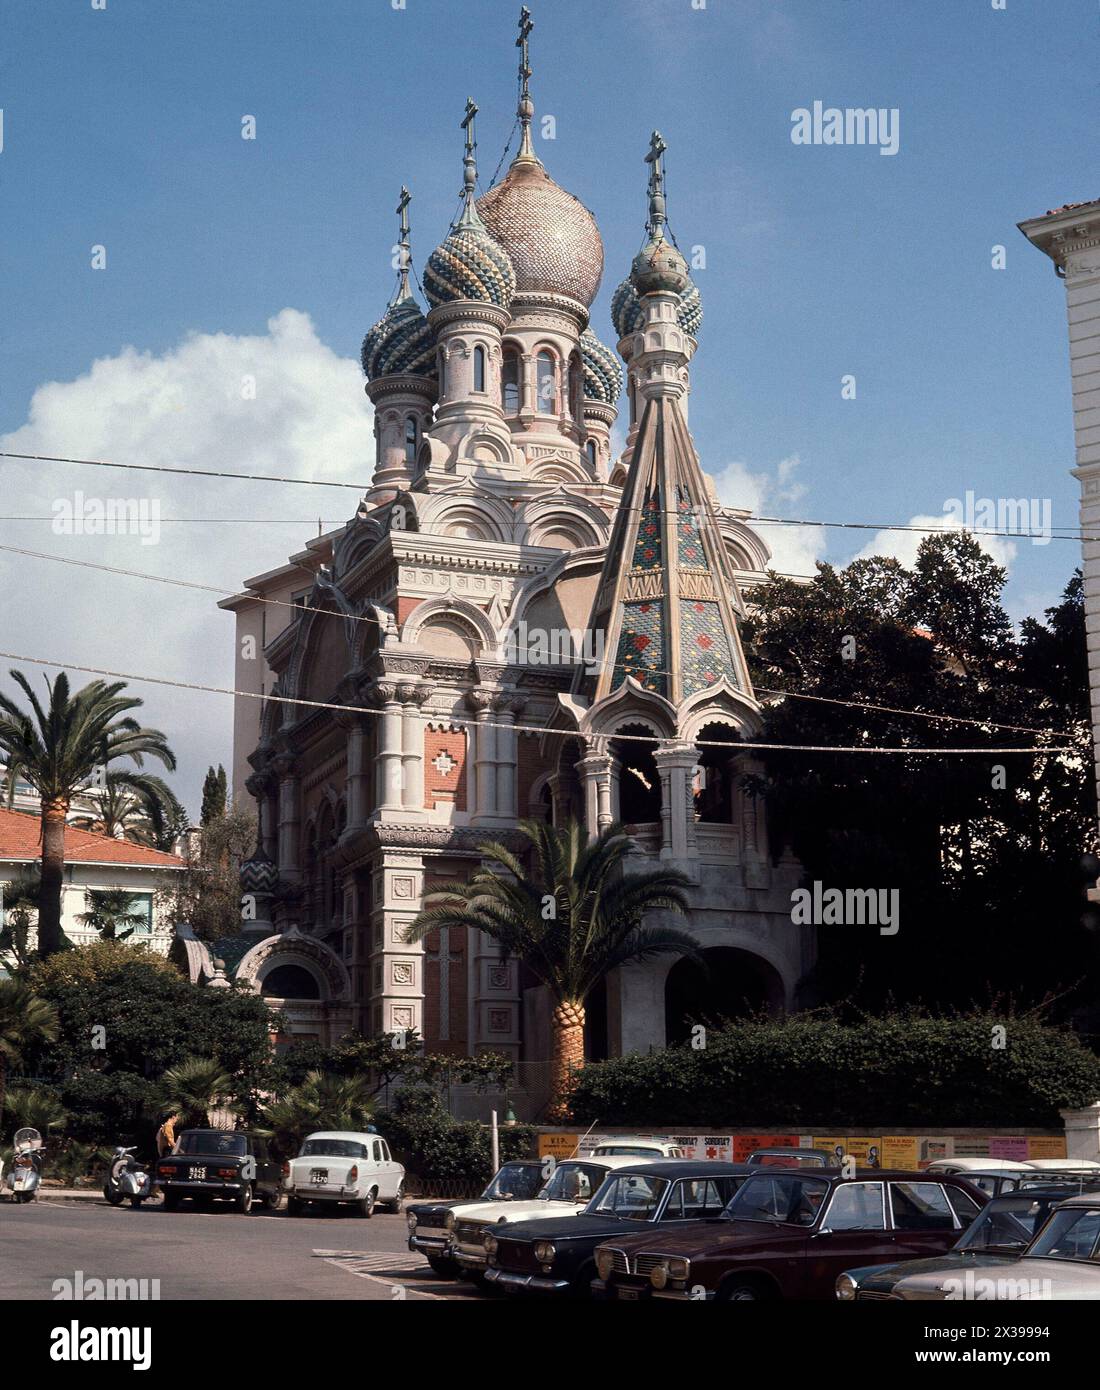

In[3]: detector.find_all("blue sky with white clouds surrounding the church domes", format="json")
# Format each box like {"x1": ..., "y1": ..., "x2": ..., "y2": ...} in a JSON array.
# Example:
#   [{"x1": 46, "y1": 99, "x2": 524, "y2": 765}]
[{"x1": 0, "y1": 0, "x2": 1100, "y2": 796}]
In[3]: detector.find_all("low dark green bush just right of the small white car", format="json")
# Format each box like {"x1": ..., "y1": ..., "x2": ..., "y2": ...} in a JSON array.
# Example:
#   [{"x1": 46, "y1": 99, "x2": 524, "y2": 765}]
[{"x1": 374, "y1": 1086, "x2": 535, "y2": 1183}]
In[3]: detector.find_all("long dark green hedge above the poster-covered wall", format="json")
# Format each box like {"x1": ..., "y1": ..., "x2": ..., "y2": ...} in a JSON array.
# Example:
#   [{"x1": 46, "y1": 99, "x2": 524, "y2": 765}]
[{"x1": 570, "y1": 1012, "x2": 1100, "y2": 1129}]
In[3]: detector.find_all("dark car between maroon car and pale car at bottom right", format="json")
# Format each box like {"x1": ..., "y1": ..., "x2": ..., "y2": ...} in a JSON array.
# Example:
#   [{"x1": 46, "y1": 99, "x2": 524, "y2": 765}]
[{"x1": 836, "y1": 1187, "x2": 1084, "y2": 1302}]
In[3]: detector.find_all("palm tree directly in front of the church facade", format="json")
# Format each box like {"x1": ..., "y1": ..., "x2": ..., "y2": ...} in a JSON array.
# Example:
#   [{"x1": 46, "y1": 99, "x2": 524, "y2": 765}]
[{"x1": 407, "y1": 820, "x2": 697, "y2": 1118}]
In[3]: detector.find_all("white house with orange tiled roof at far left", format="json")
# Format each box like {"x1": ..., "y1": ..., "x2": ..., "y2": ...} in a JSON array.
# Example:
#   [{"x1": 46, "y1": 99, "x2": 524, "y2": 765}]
[{"x1": 0, "y1": 810, "x2": 184, "y2": 963}]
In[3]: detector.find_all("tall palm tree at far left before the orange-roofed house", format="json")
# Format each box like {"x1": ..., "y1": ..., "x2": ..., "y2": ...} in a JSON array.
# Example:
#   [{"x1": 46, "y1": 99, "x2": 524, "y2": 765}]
[{"x1": 0, "y1": 671, "x2": 175, "y2": 956}]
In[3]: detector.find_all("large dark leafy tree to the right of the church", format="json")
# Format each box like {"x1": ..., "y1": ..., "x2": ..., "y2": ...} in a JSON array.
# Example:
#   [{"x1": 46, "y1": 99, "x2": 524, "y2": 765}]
[{"x1": 745, "y1": 532, "x2": 1100, "y2": 1012}]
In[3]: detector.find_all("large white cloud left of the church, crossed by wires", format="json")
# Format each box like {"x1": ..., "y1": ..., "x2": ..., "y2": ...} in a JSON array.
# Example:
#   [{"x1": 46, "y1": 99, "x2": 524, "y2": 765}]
[{"x1": 0, "y1": 309, "x2": 373, "y2": 815}]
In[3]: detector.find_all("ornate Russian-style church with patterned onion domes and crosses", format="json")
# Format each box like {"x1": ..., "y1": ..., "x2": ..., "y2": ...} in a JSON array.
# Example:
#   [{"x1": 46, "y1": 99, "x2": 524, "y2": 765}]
[{"x1": 212, "y1": 13, "x2": 815, "y2": 1061}]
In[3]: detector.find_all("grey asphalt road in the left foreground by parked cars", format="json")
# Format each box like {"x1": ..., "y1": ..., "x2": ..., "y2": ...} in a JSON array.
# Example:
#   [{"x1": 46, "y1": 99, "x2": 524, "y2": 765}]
[{"x1": 0, "y1": 1200, "x2": 487, "y2": 1301}]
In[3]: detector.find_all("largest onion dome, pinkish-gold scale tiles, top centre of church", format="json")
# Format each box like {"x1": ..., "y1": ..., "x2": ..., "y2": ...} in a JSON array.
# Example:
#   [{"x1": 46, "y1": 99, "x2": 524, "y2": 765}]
[{"x1": 477, "y1": 154, "x2": 604, "y2": 309}]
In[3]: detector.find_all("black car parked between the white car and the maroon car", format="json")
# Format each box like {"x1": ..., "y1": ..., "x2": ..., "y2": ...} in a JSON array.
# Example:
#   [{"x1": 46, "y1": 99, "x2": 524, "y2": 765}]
[{"x1": 485, "y1": 1158, "x2": 759, "y2": 1297}]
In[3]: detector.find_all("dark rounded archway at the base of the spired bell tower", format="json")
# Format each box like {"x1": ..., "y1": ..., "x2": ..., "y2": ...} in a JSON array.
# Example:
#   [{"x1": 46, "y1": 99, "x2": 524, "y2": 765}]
[{"x1": 665, "y1": 947, "x2": 784, "y2": 1047}]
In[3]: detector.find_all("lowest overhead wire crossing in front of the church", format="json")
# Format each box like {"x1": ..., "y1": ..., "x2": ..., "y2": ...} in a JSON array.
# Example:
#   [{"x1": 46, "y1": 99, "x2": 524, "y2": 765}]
[{"x1": 0, "y1": 652, "x2": 1078, "y2": 758}]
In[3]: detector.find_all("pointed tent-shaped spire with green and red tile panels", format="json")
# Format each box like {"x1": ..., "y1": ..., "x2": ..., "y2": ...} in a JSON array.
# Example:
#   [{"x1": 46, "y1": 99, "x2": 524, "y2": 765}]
[{"x1": 574, "y1": 395, "x2": 752, "y2": 705}]
